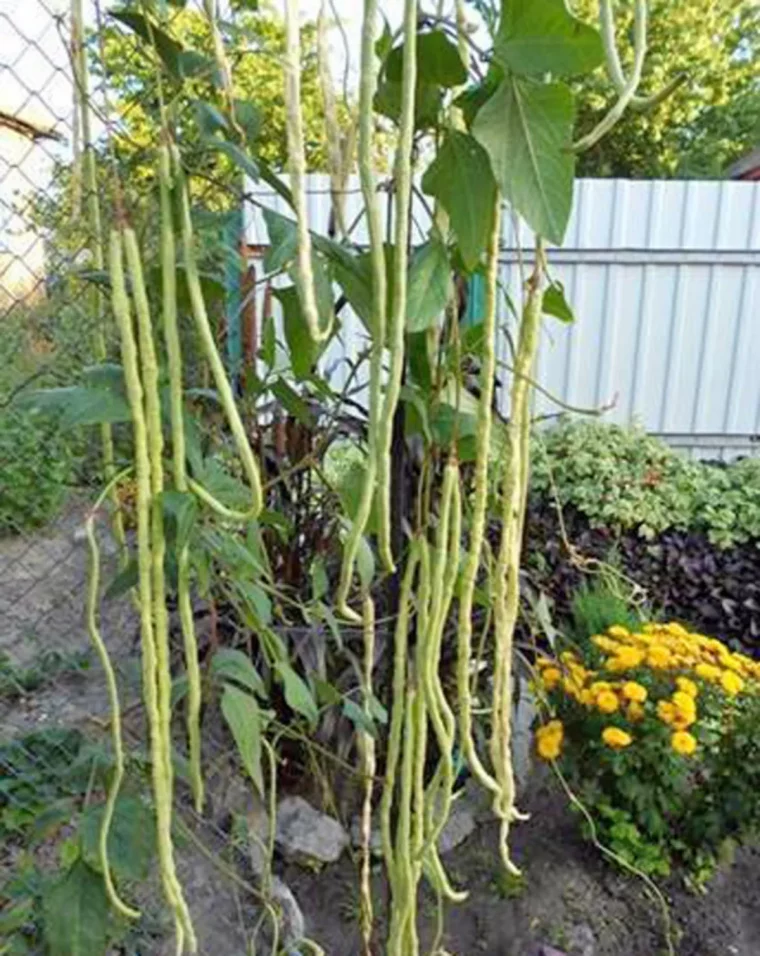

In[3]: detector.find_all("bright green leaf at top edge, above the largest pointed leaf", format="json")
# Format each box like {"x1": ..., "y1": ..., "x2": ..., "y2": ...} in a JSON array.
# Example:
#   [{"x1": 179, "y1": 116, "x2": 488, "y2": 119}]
[{"x1": 494, "y1": 0, "x2": 604, "y2": 76}]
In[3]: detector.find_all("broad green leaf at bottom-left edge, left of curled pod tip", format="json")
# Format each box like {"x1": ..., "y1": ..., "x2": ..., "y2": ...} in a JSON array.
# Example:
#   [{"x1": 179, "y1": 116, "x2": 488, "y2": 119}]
[{"x1": 43, "y1": 860, "x2": 109, "y2": 956}]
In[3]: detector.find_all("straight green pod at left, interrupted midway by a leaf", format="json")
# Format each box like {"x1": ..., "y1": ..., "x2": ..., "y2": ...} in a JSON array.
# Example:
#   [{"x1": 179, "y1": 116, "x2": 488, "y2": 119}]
[{"x1": 159, "y1": 143, "x2": 204, "y2": 813}]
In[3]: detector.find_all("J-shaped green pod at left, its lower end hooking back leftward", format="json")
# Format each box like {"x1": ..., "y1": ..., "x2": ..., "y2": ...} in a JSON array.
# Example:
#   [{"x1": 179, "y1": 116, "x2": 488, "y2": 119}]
[{"x1": 171, "y1": 145, "x2": 262, "y2": 522}]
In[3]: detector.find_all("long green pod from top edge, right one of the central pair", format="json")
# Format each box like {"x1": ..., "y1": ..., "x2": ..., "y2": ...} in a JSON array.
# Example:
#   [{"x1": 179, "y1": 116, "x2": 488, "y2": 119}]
[{"x1": 377, "y1": 0, "x2": 417, "y2": 572}]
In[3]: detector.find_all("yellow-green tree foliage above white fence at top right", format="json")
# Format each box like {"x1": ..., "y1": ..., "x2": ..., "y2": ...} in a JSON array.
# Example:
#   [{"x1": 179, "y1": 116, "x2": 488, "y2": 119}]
[{"x1": 573, "y1": 0, "x2": 760, "y2": 179}]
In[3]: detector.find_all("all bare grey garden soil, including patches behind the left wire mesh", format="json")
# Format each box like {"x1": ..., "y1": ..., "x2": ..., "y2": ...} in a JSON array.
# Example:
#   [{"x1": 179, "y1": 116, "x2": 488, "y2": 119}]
[{"x1": 0, "y1": 507, "x2": 760, "y2": 956}]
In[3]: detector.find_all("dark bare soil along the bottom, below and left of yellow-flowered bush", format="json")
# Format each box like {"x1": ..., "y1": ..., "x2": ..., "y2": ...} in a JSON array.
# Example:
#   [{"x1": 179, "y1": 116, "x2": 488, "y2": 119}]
[{"x1": 286, "y1": 772, "x2": 760, "y2": 956}]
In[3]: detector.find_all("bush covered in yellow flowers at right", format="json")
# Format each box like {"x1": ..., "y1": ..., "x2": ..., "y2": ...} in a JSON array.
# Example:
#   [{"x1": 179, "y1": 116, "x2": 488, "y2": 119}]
[{"x1": 536, "y1": 624, "x2": 760, "y2": 877}]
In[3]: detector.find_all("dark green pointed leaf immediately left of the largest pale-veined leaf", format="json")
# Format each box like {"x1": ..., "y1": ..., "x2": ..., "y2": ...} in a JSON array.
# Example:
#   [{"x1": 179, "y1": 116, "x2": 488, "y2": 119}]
[{"x1": 422, "y1": 130, "x2": 496, "y2": 270}]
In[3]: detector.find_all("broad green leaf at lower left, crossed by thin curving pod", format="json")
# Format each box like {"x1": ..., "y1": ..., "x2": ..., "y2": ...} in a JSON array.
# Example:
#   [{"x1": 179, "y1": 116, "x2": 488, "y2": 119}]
[{"x1": 79, "y1": 797, "x2": 156, "y2": 880}]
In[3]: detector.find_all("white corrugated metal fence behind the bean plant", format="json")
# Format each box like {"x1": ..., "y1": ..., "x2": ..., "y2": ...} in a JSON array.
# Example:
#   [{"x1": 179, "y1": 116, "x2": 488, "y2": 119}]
[{"x1": 246, "y1": 176, "x2": 760, "y2": 458}]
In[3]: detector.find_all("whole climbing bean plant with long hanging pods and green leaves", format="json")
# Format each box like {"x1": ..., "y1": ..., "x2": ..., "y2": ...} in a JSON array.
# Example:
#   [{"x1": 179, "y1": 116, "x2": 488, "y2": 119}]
[{"x1": 22, "y1": 0, "x2": 688, "y2": 956}]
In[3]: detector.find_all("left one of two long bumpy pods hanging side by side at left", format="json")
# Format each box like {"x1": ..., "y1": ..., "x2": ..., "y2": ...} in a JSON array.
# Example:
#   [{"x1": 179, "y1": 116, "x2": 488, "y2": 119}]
[{"x1": 109, "y1": 229, "x2": 197, "y2": 953}]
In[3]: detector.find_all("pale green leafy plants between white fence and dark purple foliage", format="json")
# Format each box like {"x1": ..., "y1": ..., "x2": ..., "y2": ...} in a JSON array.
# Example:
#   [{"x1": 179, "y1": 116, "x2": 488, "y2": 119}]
[{"x1": 531, "y1": 419, "x2": 760, "y2": 547}]
